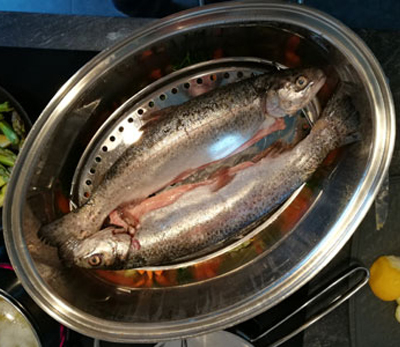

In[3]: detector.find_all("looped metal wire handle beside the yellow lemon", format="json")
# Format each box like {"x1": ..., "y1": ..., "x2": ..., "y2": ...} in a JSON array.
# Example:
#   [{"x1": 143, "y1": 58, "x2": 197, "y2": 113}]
[{"x1": 236, "y1": 266, "x2": 369, "y2": 347}]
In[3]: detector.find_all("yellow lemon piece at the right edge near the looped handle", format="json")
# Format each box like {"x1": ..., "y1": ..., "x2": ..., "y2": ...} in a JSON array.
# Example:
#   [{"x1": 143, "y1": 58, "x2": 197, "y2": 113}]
[{"x1": 369, "y1": 255, "x2": 400, "y2": 302}]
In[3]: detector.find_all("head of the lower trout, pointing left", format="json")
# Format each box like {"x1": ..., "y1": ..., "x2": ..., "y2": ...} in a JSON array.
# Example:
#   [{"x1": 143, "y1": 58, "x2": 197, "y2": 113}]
[{"x1": 59, "y1": 227, "x2": 132, "y2": 270}]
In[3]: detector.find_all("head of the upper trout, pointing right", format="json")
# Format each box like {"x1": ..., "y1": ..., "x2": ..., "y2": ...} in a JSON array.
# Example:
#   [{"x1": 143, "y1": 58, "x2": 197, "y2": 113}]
[{"x1": 263, "y1": 68, "x2": 326, "y2": 118}]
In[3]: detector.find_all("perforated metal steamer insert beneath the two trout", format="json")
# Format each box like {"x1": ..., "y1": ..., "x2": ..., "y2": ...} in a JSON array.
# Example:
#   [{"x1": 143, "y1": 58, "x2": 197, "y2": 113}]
[{"x1": 71, "y1": 57, "x2": 320, "y2": 208}]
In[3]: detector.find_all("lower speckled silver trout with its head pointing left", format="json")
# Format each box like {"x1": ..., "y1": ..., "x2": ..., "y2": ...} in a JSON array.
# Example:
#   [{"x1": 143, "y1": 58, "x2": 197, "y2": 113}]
[{"x1": 66, "y1": 85, "x2": 359, "y2": 270}]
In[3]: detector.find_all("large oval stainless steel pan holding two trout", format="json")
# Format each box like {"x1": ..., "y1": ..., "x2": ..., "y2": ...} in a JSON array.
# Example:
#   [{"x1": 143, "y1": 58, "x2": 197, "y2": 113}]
[{"x1": 3, "y1": 2, "x2": 395, "y2": 342}]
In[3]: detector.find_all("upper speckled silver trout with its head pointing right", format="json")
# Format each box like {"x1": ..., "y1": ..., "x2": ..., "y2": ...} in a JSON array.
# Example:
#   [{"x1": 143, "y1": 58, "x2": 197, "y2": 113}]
[{"x1": 38, "y1": 68, "x2": 326, "y2": 246}]
